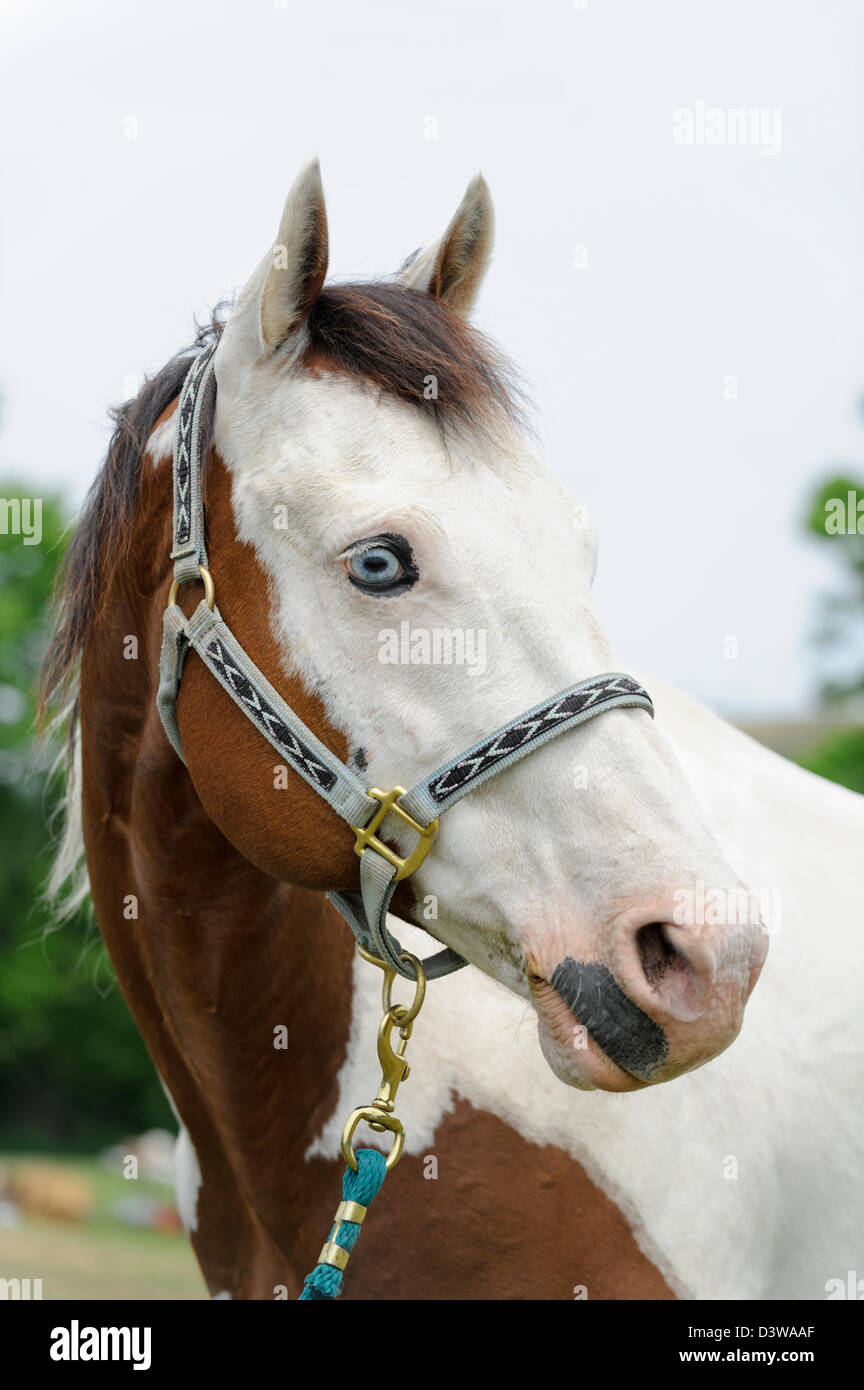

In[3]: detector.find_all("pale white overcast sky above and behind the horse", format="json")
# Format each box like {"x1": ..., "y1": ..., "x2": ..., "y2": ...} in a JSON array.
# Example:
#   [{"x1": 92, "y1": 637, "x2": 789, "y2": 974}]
[{"x1": 0, "y1": 0, "x2": 864, "y2": 713}]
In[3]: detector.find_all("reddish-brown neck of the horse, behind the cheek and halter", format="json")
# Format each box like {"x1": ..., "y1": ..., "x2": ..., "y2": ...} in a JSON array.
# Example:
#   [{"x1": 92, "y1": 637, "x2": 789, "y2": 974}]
[{"x1": 81, "y1": 442, "x2": 353, "y2": 1239}]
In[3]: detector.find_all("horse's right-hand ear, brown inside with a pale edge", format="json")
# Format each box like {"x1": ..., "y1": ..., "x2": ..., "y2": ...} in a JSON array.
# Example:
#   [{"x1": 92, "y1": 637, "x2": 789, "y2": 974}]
[{"x1": 397, "y1": 174, "x2": 495, "y2": 317}]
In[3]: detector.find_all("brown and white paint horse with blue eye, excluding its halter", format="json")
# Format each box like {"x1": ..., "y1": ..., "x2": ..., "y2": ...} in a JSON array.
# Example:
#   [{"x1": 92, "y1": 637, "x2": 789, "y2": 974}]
[{"x1": 43, "y1": 163, "x2": 864, "y2": 1300}]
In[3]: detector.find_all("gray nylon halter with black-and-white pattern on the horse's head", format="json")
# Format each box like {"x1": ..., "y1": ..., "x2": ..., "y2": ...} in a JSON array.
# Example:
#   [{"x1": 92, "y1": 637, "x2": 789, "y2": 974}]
[{"x1": 157, "y1": 346, "x2": 654, "y2": 979}]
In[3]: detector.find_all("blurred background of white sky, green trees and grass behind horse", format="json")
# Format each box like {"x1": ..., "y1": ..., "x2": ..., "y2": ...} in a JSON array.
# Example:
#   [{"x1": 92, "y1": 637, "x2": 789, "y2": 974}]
[{"x1": 0, "y1": 0, "x2": 864, "y2": 1298}]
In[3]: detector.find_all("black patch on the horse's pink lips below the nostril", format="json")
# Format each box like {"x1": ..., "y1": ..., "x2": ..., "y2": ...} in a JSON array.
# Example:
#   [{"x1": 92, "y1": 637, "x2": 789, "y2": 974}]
[{"x1": 549, "y1": 956, "x2": 670, "y2": 1081}]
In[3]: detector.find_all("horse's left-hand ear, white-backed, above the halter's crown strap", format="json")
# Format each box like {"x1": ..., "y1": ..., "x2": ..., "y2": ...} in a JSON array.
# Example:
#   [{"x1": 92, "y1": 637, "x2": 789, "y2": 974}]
[{"x1": 217, "y1": 160, "x2": 328, "y2": 391}]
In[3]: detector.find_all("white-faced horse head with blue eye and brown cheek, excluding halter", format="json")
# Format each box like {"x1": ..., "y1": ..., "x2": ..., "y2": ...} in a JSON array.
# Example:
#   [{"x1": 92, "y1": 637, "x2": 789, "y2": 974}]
[{"x1": 161, "y1": 164, "x2": 765, "y2": 1090}]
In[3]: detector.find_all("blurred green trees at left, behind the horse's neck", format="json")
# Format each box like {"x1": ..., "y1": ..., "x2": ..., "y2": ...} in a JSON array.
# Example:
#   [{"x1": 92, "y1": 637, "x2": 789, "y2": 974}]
[{"x1": 0, "y1": 482, "x2": 172, "y2": 1152}]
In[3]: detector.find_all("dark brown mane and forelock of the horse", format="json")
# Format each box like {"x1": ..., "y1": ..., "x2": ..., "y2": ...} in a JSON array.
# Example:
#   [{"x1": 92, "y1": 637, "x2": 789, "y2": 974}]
[{"x1": 40, "y1": 282, "x2": 524, "y2": 712}]
